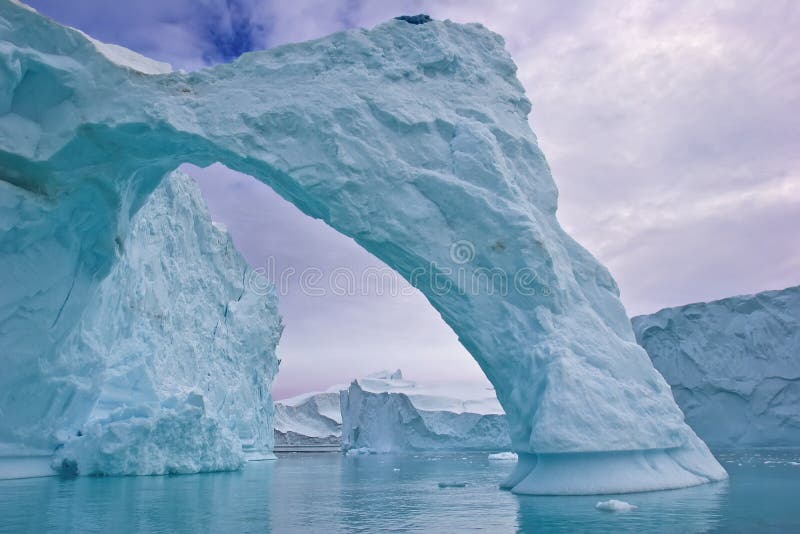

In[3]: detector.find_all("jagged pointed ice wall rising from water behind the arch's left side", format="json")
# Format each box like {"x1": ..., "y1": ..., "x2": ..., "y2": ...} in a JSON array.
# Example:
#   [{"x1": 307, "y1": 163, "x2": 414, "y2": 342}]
[{"x1": 1, "y1": 172, "x2": 281, "y2": 475}]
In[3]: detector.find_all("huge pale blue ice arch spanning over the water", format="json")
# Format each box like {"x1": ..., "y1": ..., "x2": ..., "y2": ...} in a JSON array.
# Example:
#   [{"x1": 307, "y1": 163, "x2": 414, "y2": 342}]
[{"x1": 0, "y1": 2, "x2": 726, "y2": 493}]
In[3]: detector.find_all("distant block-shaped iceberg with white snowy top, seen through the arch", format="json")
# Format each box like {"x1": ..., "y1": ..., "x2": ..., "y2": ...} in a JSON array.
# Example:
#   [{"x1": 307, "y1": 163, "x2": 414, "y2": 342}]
[{"x1": 341, "y1": 370, "x2": 511, "y2": 452}]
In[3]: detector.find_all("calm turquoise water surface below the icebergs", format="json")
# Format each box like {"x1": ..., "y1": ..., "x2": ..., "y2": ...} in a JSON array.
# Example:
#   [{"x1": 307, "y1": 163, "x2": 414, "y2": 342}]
[{"x1": 0, "y1": 450, "x2": 800, "y2": 533}]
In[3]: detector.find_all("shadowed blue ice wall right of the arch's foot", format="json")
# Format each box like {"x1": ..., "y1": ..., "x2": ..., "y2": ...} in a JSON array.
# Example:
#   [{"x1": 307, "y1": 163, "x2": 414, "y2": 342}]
[{"x1": 632, "y1": 286, "x2": 800, "y2": 448}]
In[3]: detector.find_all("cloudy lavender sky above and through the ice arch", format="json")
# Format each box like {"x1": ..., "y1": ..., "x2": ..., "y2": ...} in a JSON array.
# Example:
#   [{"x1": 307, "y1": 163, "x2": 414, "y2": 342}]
[{"x1": 28, "y1": 0, "x2": 800, "y2": 398}]
